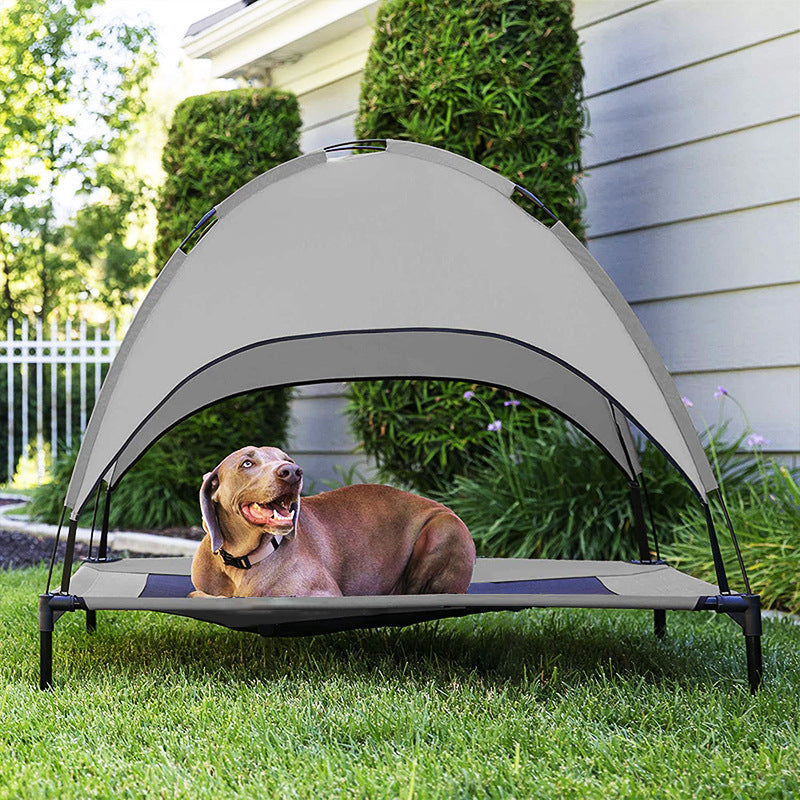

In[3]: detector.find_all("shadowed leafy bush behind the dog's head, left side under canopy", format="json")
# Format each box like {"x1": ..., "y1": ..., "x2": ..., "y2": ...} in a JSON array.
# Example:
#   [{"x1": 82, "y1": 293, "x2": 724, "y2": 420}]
[{"x1": 30, "y1": 392, "x2": 289, "y2": 529}]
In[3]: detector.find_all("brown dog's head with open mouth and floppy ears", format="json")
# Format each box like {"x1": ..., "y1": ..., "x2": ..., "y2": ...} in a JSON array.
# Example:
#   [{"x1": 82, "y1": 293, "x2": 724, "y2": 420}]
[{"x1": 200, "y1": 447, "x2": 303, "y2": 555}]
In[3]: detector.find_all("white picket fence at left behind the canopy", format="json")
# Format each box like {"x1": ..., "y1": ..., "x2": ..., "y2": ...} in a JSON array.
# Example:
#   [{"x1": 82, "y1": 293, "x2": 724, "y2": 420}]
[{"x1": 0, "y1": 320, "x2": 120, "y2": 481}]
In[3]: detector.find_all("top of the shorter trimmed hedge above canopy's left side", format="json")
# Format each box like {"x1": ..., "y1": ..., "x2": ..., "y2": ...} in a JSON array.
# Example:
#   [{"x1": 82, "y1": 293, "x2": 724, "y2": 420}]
[{"x1": 155, "y1": 89, "x2": 300, "y2": 266}]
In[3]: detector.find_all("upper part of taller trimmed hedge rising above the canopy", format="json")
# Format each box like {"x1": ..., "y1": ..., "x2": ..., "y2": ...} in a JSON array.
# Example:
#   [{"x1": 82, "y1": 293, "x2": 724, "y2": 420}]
[{"x1": 355, "y1": 0, "x2": 585, "y2": 238}]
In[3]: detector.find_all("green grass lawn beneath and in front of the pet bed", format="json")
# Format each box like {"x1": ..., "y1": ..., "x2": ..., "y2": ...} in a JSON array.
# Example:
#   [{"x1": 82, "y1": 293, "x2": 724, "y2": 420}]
[{"x1": 0, "y1": 568, "x2": 800, "y2": 800}]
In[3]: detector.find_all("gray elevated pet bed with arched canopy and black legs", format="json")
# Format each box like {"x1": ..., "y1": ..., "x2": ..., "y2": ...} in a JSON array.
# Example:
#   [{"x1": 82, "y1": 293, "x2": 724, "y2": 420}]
[{"x1": 39, "y1": 140, "x2": 762, "y2": 691}]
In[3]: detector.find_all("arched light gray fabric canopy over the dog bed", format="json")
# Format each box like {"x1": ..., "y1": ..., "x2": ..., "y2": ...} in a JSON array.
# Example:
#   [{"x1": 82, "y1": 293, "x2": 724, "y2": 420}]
[{"x1": 65, "y1": 141, "x2": 716, "y2": 519}]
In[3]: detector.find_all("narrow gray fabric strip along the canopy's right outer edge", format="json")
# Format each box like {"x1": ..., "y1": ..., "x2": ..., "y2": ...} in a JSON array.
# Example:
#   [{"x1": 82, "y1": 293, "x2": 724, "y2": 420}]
[{"x1": 551, "y1": 222, "x2": 717, "y2": 495}]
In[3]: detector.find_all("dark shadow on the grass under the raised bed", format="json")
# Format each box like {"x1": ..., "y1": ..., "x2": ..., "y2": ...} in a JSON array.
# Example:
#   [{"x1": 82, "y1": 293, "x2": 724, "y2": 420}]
[{"x1": 56, "y1": 610, "x2": 744, "y2": 692}]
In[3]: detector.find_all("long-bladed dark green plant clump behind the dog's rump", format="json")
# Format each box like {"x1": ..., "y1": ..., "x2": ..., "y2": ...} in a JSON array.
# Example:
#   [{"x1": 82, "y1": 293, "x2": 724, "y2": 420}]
[{"x1": 435, "y1": 396, "x2": 757, "y2": 559}]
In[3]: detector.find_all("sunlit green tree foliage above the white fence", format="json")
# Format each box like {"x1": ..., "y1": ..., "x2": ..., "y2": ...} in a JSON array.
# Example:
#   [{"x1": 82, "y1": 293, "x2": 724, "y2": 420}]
[{"x1": 0, "y1": 0, "x2": 155, "y2": 322}]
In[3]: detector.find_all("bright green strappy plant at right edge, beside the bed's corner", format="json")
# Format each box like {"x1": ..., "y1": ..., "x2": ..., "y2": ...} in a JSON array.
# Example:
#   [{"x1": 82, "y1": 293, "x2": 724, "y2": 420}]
[{"x1": 666, "y1": 460, "x2": 800, "y2": 614}]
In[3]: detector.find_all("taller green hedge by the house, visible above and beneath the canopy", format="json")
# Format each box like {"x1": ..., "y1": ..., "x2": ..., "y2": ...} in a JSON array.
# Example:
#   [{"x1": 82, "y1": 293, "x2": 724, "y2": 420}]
[{"x1": 349, "y1": 0, "x2": 585, "y2": 493}]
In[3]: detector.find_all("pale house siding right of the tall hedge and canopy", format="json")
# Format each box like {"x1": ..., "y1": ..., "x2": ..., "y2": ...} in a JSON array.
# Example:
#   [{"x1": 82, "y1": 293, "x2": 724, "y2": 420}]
[{"x1": 576, "y1": 0, "x2": 800, "y2": 464}]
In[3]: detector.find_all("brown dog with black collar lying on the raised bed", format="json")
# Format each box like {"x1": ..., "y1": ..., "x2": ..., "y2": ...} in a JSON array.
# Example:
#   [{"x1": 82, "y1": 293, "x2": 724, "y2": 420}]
[{"x1": 191, "y1": 447, "x2": 475, "y2": 597}]
